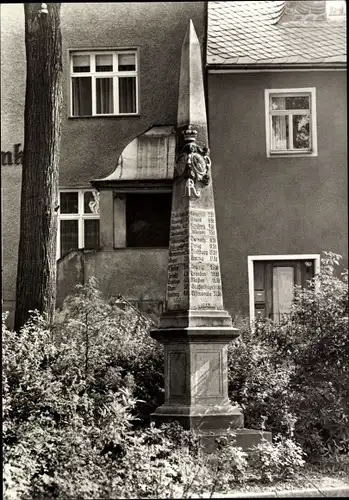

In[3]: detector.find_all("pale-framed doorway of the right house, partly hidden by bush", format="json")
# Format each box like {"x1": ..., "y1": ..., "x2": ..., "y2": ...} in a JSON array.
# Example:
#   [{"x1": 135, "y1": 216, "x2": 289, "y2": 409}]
[{"x1": 248, "y1": 254, "x2": 320, "y2": 323}]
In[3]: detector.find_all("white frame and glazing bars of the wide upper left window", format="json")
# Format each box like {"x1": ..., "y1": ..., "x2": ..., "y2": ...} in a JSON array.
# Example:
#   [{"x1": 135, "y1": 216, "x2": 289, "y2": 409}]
[{"x1": 69, "y1": 49, "x2": 139, "y2": 118}]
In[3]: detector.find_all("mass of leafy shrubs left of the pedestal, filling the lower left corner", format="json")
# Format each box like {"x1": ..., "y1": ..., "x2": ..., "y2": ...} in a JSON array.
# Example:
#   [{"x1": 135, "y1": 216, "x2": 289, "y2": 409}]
[{"x1": 2, "y1": 281, "x2": 304, "y2": 500}]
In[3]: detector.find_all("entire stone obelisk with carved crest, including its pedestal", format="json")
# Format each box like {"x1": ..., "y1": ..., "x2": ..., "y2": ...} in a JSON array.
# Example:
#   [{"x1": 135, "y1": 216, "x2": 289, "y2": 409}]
[{"x1": 151, "y1": 21, "x2": 270, "y2": 448}]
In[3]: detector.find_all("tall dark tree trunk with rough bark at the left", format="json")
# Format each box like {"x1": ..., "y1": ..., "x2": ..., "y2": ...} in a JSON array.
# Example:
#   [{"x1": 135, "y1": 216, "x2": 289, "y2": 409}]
[{"x1": 15, "y1": 3, "x2": 62, "y2": 331}]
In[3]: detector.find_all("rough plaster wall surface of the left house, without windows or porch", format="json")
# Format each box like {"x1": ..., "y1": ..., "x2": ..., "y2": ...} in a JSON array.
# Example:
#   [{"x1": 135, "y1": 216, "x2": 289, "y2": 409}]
[{"x1": 1, "y1": 1, "x2": 205, "y2": 324}]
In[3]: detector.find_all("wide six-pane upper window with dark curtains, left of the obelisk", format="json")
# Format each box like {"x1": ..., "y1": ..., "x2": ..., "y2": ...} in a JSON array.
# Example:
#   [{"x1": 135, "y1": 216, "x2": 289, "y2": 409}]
[{"x1": 70, "y1": 50, "x2": 138, "y2": 116}]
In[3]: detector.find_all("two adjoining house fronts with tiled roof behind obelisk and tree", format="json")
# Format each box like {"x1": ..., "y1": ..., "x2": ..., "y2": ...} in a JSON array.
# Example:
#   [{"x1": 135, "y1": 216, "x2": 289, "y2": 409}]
[{"x1": 1, "y1": 1, "x2": 347, "y2": 328}]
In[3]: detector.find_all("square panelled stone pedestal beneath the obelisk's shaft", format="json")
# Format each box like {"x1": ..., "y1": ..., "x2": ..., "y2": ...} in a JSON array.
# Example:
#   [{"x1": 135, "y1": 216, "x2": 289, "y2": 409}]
[{"x1": 151, "y1": 327, "x2": 244, "y2": 431}]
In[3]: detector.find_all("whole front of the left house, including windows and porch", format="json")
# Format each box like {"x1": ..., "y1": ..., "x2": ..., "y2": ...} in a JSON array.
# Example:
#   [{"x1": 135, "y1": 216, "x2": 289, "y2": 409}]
[{"x1": 1, "y1": 2, "x2": 206, "y2": 326}]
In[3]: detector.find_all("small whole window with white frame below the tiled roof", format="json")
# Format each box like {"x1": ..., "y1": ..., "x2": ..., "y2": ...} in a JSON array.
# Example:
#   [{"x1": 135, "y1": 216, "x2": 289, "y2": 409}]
[{"x1": 265, "y1": 88, "x2": 317, "y2": 157}]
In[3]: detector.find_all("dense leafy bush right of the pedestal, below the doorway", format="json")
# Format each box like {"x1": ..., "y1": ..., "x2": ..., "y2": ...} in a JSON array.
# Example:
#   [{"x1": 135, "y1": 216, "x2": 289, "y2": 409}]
[{"x1": 228, "y1": 252, "x2": 349, "y2": 459}]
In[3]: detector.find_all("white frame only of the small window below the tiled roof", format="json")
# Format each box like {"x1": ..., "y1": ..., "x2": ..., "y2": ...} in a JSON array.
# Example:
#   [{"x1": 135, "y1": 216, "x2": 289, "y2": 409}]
[{"x1": 264, "y1": 87, "x2": 318, "y2": 158}]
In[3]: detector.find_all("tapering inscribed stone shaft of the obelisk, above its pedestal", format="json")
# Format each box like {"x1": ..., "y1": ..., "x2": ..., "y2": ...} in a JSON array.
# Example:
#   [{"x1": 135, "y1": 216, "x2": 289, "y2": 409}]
[{"x1": 160, "y1": 21, "x2": 232, "y2": 328}]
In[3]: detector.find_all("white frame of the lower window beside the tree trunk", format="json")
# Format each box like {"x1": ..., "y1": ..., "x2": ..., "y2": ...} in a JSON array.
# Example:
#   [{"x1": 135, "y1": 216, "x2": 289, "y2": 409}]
[{"x1": 56, "y1": 188, "x2": 100, "y2": 260}]
